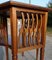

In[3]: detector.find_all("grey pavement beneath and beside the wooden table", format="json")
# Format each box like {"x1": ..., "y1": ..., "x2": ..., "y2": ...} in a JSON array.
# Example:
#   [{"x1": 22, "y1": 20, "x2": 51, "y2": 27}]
[{"x1": 0, "y1": 36, "x2": 52, "y2": 60}]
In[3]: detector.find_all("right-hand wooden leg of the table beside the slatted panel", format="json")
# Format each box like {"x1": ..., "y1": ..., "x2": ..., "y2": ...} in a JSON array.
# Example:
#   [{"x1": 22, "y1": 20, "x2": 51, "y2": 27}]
[{"x1": 40, "y1": 12, "x2": 48, "y2": 60}]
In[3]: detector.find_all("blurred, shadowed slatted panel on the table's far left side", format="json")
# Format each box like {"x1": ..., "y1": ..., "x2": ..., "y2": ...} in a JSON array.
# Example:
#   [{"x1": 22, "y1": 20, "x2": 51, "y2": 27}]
[{"x1": 0, "y1": 17, "x2": 7, "y2": 44}]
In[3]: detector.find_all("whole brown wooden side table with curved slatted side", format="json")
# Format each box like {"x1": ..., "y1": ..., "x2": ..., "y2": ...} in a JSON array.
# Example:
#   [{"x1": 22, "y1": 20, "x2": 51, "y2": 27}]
[{"x1": 0, "y1": 1, "x2": 52, "y2": 60}]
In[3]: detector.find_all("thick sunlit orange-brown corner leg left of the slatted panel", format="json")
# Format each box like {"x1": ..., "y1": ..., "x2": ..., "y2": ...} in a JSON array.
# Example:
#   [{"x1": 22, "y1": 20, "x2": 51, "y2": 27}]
[{"x1": 10, "y1": 7, "x2": 17, "y2": 60}]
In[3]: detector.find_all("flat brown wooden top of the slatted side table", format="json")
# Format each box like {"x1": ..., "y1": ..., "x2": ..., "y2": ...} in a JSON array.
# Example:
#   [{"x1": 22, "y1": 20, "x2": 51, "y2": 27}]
[{"x1": 0, "y1": 1, "x2": 52, "y2": 11}]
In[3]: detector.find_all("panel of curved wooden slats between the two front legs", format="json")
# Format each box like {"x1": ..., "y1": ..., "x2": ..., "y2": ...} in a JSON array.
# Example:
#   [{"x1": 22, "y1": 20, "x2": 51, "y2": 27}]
[{"x1": 18, "y1": 12, "x2": 42, "y2": 48}]
